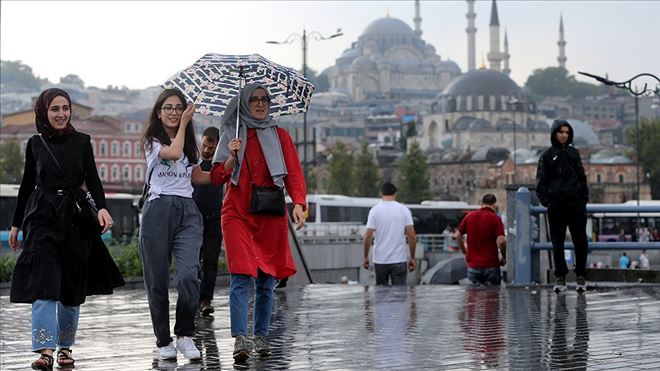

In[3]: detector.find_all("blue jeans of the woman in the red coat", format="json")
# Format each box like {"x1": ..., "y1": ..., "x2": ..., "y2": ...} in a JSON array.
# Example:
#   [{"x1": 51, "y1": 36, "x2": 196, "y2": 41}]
[{"x1": 229, "y1": 271, "x2": 277, "y2": 337}]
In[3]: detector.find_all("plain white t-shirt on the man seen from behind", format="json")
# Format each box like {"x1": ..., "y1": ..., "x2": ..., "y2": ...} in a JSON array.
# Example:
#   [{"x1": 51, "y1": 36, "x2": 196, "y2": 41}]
[{"x1": 367, "y1": 201, "x2": 413, "y2": 264}]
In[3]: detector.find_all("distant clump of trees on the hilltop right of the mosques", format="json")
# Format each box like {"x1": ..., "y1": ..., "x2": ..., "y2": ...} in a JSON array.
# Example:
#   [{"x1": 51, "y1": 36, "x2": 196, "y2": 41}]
[{"x1": 525, "y1": 67, "x2": 603, "y2": 101}]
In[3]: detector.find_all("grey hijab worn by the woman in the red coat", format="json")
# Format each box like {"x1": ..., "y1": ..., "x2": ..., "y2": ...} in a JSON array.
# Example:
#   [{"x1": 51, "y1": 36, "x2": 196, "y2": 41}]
[{"x1": 213, "y1": 83, "x2": 287, "y2": 188}]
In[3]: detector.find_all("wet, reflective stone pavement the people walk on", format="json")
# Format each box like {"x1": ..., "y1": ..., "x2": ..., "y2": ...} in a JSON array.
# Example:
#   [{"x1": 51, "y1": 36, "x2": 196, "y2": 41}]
[{"x1": 0, "y1": 285, "x2": 660, "y2": 370}]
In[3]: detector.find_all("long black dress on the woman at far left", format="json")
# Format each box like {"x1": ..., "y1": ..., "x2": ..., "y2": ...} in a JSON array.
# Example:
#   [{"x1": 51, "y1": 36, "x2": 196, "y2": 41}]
[{"x1": 10, "y1": 131, "x2": 124, "y2": 306}]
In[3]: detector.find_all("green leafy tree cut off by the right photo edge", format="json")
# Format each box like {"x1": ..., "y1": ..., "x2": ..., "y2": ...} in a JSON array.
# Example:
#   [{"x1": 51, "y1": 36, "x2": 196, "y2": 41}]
[{"x1": 626, "y1": 117, "x2": 660, "y2": 200}]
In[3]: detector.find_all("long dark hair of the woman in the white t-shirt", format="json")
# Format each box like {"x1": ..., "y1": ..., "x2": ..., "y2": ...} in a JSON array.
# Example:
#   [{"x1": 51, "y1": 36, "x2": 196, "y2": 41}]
[{"x1": 142, "y1": 89, "x2": 199, "y2": 164}]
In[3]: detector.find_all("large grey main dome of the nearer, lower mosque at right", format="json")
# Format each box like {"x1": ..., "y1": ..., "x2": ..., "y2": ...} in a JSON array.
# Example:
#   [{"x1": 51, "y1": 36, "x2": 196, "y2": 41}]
[{"x1": 441, "y1": 69, "x2": 520, "y2": 96}]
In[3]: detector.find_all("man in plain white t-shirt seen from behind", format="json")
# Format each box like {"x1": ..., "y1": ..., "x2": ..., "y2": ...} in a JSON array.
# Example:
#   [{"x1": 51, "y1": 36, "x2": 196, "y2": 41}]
[{"x1": 362, "y1": 183, "x2": 416, "y2": 285}]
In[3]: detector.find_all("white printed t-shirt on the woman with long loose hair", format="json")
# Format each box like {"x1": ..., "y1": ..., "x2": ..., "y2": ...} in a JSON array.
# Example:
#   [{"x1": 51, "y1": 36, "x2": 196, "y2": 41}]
[{"x1": 144, "y1": 139, "x2": 199, "y2": 200}]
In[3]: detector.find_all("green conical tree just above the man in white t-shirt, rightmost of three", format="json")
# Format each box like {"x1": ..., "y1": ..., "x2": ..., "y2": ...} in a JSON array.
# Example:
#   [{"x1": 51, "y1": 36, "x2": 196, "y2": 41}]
[{"x1": 397, "y1": 141, "x2": 430, "y2": 203}]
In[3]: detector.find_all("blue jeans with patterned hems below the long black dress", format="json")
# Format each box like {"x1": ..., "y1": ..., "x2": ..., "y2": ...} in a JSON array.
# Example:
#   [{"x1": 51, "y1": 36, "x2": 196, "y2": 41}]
[{"x1": 32, "y1": 299, "x2": 80, "y2": 352}]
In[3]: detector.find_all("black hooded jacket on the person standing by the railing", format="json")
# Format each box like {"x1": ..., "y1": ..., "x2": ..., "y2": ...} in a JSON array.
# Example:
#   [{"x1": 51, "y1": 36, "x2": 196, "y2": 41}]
[{"x1": 536, "y1": 120, "x2": 589, "y2": 207}]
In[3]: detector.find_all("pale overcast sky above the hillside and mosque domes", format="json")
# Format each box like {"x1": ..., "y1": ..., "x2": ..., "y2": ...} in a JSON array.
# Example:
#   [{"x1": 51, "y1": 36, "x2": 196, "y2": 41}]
[{"x1": 0, "y1": 0, "x2": 660, "y2": 88}]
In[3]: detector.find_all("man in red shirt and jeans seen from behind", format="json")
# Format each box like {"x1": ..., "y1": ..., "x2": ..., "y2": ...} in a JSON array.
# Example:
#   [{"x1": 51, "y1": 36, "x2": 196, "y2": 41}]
[{"x1": 455, "y1": 193, "x2": 506, "y2": 286}]
